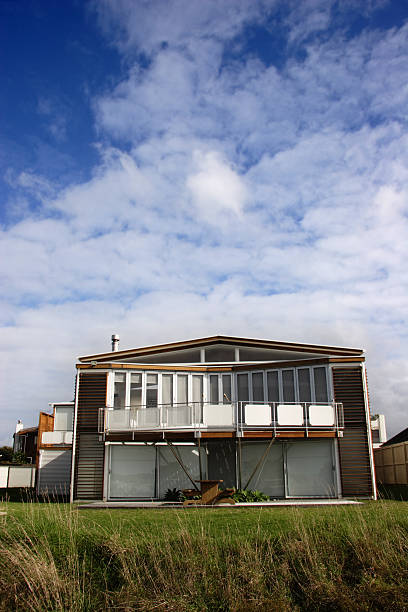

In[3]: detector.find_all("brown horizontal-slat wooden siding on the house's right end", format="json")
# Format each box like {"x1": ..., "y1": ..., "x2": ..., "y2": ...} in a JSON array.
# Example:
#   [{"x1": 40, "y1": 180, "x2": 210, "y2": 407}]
[{"x1": 333, "y1": 367, "x2": 373, "y2": 497}]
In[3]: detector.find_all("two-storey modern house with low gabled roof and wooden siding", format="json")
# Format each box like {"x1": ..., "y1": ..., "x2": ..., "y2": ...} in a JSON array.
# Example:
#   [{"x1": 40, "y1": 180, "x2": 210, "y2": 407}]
[{"x1": 71, "y1": 336, "x2": 376, "y2": 500}]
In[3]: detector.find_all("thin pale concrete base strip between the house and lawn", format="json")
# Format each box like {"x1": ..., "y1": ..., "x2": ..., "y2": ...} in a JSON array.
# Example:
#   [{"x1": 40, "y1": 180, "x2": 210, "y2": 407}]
[{"x1": 77, "y1": 499, "x2": 363, "y2": 510}]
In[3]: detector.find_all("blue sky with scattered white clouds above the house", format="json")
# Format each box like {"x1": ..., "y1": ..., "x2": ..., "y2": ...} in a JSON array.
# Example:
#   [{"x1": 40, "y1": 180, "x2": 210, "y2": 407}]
[{"x1": 0, "y1": 0, "x2": 408, "y2": 443}]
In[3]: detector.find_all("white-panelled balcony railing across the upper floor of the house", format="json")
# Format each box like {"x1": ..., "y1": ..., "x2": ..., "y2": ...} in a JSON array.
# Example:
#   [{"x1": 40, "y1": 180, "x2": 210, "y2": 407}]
[{"x1": 99, "y1": 402, "x2": 344, "y2": 433}]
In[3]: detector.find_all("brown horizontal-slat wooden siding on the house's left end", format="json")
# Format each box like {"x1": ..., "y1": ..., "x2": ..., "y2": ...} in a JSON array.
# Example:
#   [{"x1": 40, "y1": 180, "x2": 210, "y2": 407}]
[{"x1": 74, "y1": 372, "x2": 107, "y2": 499}]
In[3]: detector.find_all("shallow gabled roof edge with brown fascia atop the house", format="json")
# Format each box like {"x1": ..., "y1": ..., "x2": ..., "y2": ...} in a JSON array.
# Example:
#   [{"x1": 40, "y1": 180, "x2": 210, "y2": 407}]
[{"x1": 79, "y1": 336, "x2": 364, "y2": 362}]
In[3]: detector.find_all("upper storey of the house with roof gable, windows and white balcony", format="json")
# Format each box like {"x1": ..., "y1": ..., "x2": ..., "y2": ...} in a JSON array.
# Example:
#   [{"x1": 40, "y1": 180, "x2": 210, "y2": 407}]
[{"x1": 77, "y1": 336, "x2": 364, "y2": 435}]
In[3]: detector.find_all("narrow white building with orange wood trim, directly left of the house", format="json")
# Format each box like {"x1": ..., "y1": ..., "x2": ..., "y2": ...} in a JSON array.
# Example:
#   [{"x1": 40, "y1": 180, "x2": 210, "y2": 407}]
[{"x1": 37, "y1": 402, "x2": 74, "y2": 496}]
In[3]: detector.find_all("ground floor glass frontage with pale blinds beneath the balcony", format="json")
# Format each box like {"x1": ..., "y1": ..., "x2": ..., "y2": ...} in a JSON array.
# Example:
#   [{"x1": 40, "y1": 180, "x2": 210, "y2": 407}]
[{"x1": 104, "y1": 439, "x2": 341, "y2": 501}]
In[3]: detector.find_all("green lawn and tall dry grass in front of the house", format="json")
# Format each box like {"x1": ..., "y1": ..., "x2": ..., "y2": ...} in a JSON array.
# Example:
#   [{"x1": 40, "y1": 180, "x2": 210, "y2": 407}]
[{"x1": 0, "y1": 501, "x2": 408, "y2": 612}]
